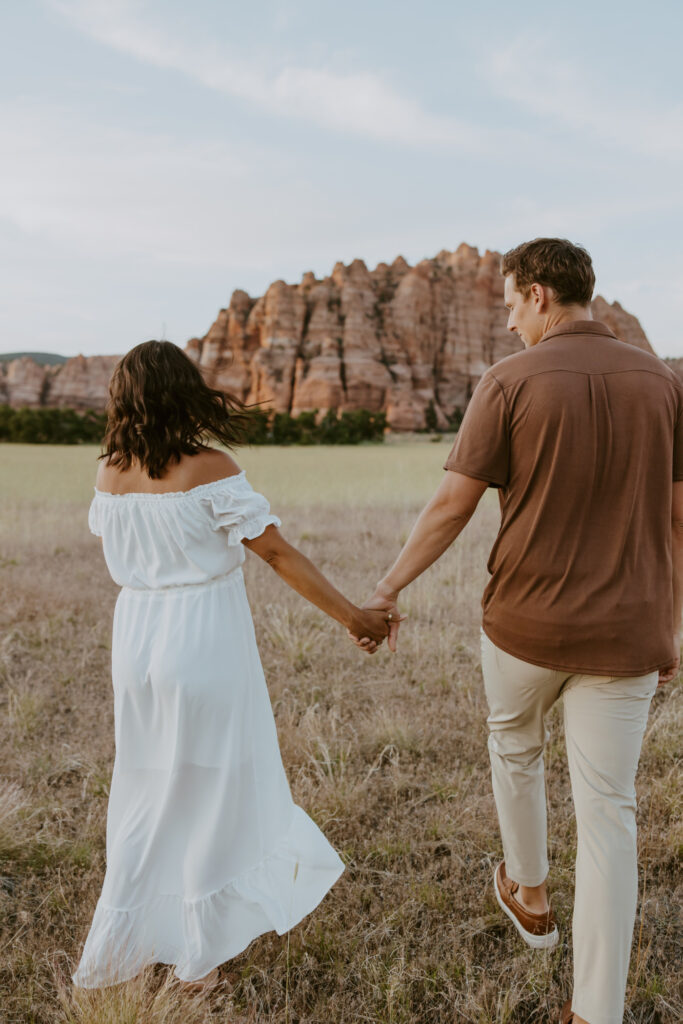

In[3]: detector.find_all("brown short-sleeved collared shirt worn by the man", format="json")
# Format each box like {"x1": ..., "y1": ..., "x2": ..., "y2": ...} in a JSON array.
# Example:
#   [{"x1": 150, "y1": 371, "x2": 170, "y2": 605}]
[{"x1": 444, "y1": 321, "x2": 683, "y2": 676}]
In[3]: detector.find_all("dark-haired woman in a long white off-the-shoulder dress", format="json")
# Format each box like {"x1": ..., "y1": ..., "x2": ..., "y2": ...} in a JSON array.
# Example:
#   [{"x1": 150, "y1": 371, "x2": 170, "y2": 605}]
[{"x1": 74, "y1": 341, "x2": 388, "y2": 988}]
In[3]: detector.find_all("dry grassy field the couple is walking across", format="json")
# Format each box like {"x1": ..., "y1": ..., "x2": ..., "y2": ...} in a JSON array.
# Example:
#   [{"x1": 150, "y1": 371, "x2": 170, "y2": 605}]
[{"x1": 0, "y1": 442, "x2": 683, "y2": 1024}]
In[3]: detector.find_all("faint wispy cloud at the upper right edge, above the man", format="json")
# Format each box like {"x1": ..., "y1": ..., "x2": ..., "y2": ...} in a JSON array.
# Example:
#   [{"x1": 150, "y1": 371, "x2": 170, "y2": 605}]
[{"x1": 482, "y1": 35, "x2": 683, "y2": 161}]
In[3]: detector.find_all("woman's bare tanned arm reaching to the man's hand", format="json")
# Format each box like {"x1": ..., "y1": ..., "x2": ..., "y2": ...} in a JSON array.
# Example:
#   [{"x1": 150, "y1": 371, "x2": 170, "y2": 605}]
[{"x1": 242, "y1": 526, "x2": 389, "y2": 643}]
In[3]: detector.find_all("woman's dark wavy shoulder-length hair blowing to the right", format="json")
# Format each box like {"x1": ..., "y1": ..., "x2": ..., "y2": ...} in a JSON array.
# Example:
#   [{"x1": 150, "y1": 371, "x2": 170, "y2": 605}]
[{"x1": 99, "y1": 341, "x2": 248, "y2": 479}]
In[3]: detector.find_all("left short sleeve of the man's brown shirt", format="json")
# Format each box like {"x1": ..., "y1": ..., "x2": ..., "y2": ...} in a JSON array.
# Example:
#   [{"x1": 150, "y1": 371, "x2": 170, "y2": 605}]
[{"x1": 443, "y1": 371, "x2": 509, "y2": 487}]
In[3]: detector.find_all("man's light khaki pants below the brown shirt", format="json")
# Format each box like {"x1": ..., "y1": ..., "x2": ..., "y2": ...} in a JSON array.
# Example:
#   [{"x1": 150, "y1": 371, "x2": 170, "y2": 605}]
[{"x1": 481, "y1": 632, "x2": 657, "y2": 1024}]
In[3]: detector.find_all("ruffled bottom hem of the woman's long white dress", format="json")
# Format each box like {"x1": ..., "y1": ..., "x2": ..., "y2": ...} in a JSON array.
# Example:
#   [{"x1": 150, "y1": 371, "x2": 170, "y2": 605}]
[{"x1": 72, "y1": 806, "x2": 344, "y2": 988}]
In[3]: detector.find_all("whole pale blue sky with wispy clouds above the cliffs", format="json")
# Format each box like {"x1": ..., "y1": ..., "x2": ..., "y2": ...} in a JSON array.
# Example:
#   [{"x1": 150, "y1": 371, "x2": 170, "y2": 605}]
[{"x1": 0, "y1": 0, "x2": 683, "y2": 355}]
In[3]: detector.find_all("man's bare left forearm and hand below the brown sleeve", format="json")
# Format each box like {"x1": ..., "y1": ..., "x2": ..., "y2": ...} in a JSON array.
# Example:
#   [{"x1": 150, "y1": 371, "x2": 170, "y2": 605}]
[{"x1": 352, "y1": 470, "x2": 488, "y2": 650}]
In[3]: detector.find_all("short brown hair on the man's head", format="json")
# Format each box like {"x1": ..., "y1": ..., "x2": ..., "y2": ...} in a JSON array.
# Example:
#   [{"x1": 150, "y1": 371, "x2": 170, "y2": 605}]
[{"x1": 501, "y1": 239, "x2": 595, "y2": 306}]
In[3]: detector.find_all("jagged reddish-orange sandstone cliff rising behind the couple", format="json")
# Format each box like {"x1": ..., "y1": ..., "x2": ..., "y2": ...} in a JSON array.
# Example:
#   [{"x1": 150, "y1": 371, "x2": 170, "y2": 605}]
[{"x1": 0, "y1": 244, "x2": 663, "y2": 430}]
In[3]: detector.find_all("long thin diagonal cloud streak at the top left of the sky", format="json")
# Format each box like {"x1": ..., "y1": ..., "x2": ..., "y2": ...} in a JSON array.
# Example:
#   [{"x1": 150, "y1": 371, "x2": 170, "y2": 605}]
[{"x1": 51, "y1": 0, "x2": 496, "y2": 152}]
